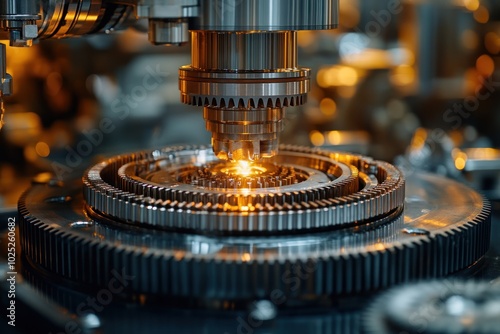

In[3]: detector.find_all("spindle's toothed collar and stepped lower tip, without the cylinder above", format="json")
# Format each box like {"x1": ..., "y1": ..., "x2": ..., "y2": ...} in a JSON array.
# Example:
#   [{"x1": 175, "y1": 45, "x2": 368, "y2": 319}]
[{"x1": 179, "y1": 66, "x2": 310, "y2": 161}]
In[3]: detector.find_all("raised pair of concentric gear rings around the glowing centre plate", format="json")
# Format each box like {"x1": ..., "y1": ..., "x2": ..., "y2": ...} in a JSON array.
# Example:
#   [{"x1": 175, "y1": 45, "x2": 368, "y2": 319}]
[{"x1": 83, "y1": 147, "x2": 404, "y2": 233}]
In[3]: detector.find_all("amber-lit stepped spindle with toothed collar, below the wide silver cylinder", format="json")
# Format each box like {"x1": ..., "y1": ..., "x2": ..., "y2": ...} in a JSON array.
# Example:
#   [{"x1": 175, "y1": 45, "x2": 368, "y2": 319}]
[{"x1": 179, "y1": 31, "x2": 310, "y2": 161}]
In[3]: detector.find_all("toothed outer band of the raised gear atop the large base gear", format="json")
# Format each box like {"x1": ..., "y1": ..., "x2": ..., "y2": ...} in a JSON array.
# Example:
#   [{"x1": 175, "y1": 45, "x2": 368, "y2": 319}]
[{"x1": 83, "y1": 146, "x2": 405, "y2": 233}]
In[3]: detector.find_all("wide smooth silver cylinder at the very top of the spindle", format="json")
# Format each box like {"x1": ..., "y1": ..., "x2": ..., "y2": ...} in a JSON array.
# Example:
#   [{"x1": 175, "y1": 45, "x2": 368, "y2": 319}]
[{"x1": 194, "y1": 0, "x2": 338, "y2": 31}]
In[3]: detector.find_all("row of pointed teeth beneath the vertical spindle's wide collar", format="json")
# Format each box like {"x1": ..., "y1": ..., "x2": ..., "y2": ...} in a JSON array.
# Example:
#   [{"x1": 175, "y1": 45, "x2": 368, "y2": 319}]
[{"x1": 181, "y1": 94, "x2": 307, "y2": 109}]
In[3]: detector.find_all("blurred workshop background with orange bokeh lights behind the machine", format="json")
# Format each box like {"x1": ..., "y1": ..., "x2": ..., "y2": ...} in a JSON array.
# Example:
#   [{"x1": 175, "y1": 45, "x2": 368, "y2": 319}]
[{"x1": 0, "y1": 0, "x2": 500, "y2": 211}]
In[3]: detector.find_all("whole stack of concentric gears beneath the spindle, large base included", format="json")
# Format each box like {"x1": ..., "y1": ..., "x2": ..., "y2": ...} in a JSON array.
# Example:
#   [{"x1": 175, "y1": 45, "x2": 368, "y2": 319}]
[{"x1": 19, "y1": 147, "x2": 490, "y2": 305}]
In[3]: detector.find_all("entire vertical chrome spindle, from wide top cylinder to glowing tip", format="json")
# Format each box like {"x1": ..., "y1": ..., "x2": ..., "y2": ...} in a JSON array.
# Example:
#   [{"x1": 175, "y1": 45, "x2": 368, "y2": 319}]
[{"x1": 179, "y1": 0, "x2": 338, "y2": 160}]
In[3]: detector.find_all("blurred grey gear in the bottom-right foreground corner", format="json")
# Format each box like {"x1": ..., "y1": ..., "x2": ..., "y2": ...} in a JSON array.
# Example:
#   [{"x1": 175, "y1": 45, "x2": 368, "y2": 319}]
[{"x1": 363, "y1": 280, "x2": 500, "y2": 334}]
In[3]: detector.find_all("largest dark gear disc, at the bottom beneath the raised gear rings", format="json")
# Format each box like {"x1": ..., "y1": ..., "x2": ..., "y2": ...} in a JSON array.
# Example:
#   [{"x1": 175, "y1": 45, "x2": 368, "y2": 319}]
[{"x1": 19, "y1": 172, "x2": 490, "y2": 302}]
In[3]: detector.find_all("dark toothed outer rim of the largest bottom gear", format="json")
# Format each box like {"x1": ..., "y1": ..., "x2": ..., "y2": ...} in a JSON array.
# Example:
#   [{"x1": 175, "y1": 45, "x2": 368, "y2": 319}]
[{"x1": 20, "y1": 179, "x2": 489, "y2": 299}]
